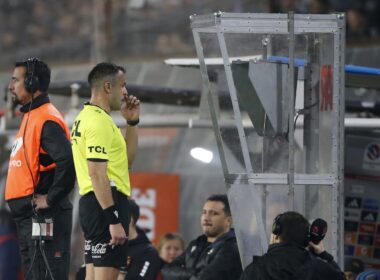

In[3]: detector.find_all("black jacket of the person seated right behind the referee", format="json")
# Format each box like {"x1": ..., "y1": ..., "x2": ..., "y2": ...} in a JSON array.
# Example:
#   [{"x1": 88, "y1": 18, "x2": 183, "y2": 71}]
[{"x1": 121, "y1": 228, "x2": 162, "y2": 280}]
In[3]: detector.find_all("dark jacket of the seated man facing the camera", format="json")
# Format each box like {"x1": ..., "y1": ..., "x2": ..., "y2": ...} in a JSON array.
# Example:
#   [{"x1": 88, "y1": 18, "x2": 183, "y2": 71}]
[{"x1": 162, "y1": 230, "x2": 242, "y2": 280}]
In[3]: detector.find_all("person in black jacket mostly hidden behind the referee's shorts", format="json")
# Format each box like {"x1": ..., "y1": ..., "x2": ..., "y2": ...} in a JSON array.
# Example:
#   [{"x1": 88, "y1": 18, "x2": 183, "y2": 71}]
[{"x1": 118, "y1": 200, "x2": 162, "y2": 280}]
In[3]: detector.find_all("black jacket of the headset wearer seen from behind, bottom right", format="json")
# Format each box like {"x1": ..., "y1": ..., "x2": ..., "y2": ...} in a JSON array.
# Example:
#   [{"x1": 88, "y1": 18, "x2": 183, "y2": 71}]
[{"x1": 240, "y1": 243, "x2": 344, "y2": 280}]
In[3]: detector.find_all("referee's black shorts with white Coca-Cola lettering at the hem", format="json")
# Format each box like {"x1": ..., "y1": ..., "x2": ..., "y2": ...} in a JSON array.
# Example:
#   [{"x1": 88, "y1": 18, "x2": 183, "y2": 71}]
[{"x1": 79, "y1": 187, "x2": 130, "y2": 268}]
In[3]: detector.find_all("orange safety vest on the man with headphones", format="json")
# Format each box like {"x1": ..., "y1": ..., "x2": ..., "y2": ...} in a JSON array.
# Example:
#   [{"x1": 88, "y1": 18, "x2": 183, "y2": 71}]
[{"x1": 5, "y1": 103, "x2": 70, "y2": 200}]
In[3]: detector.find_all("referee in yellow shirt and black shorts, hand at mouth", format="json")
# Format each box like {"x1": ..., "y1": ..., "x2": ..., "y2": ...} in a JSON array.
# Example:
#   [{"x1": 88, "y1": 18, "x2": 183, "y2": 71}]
[{"x1": 71, "y1": 63, "x2": 140, "y2": 280}]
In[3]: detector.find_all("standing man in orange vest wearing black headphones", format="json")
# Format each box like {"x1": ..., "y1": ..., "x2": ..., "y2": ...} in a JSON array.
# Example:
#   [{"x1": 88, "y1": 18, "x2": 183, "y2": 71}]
[{"x1": 5, "y1": 58, "x2": 75, "y2": 280}]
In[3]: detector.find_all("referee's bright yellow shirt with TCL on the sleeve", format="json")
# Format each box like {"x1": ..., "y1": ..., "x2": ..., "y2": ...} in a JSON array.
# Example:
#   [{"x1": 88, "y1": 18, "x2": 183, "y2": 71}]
[{"x1": 71, "y1": 104, "x2": 131, "y2": 196}]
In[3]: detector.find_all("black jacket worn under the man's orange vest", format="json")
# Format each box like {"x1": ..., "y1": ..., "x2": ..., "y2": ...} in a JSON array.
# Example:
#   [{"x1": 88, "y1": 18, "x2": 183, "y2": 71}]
[{"x1": 8, "y1": 93, "x2": 75, "y2": 220}]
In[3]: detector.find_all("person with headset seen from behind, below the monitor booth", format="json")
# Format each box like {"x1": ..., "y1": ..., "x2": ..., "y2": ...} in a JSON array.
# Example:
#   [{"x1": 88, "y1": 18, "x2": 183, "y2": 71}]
[{"x1": 240, "y1": 212, "x2": 344, "y2": 280}]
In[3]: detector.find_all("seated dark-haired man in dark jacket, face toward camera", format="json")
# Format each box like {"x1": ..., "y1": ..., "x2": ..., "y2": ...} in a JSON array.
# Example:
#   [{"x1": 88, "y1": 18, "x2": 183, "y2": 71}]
[{"x1": 162, "y1": 195, "x2": 242, "y2": 280}]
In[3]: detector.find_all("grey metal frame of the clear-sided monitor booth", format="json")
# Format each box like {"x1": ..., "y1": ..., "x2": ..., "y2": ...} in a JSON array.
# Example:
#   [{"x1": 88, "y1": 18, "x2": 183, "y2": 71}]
[{"x1": 190, "y1": 12, "x2": 345, "y2": 263}]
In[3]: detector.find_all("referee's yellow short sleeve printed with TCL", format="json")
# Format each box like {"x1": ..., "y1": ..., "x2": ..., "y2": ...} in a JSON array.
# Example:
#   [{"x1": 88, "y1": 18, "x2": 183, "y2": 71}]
[{"x1": 85, "y1": 118, "x2": 114, "y2": 161}]
